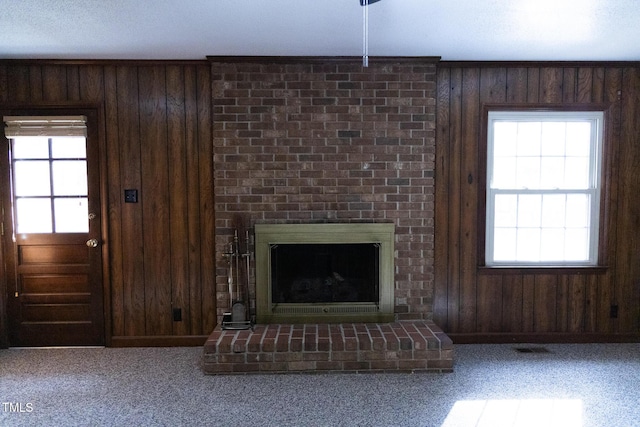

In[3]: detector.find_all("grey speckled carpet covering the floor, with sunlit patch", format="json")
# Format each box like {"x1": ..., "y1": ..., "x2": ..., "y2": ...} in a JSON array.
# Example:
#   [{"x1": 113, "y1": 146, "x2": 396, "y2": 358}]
[{"x1": 0, "y1": 344, "x2": 640, "y2": 427}]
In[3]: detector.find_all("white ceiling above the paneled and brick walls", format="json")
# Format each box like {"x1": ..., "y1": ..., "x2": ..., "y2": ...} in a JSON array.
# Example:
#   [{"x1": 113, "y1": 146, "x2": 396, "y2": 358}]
[{"x1": 0, "y1": 0, "x2": 640, "y2": 61}]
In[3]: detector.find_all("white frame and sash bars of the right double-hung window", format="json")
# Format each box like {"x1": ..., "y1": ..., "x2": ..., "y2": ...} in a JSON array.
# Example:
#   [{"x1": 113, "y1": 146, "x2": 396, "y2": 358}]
[{"x1": 485, "y1": 110, "x2": 604, "y2": 267}]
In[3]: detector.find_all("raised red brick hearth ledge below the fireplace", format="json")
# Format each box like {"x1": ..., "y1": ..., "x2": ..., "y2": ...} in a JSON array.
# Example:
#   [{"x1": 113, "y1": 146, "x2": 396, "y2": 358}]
[{"x1": 203, "y1": 320, "x2": 453, "y2": 374}]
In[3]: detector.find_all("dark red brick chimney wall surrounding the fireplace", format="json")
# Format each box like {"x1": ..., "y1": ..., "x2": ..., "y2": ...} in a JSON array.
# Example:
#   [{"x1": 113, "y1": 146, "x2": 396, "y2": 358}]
[{"x1": 212, "y1": 58, "x2": 436, "y2": 320}]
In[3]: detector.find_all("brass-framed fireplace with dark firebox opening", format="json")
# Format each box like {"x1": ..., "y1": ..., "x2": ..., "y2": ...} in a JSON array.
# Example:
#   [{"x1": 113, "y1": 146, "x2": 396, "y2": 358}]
[{"x1": 255, "y1": 223, "x2": 394, "y2": 323}]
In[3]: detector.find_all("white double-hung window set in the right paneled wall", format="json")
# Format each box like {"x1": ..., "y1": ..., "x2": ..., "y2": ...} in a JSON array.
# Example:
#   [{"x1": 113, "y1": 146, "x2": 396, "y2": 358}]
[{"x1": 485, "y1": 111, "x2": 604, "y2": 267}]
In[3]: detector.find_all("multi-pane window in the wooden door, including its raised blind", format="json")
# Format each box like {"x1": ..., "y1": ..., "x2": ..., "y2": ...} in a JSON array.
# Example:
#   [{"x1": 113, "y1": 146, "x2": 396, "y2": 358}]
[{"x1": 5, "y1": 116, "x2": 89, "y2": 233}]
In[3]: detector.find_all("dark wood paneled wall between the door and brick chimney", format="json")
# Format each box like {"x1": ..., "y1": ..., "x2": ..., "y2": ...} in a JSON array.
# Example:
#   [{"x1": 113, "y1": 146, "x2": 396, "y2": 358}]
[{"x1": 0, "y1": 61, "x2": 216, "y2": 345}]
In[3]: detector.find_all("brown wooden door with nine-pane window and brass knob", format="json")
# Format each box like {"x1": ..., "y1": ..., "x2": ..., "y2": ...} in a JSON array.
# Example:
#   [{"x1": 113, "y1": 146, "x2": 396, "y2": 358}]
[{"x1": 2, "y1": 110, "x2": 105, "y2": 346}]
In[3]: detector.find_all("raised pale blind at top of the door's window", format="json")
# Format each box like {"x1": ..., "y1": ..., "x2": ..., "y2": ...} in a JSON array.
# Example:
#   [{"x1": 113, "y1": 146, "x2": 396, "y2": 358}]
[{"x1": 4, "y1": 116, "x2": 87, "y2": 139}]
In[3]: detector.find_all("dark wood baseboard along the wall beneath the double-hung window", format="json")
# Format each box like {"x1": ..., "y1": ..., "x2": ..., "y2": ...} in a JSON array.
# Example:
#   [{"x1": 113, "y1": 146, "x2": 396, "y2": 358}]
[{"x1": 447, "y1": 333, "x2": 640, "y2": 344}]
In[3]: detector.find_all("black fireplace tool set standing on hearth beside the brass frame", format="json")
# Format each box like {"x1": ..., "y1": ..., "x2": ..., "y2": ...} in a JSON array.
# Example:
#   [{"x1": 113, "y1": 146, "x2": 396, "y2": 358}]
[{"x1": 222, "y1": 230, "x2": 252, "y2": 330}]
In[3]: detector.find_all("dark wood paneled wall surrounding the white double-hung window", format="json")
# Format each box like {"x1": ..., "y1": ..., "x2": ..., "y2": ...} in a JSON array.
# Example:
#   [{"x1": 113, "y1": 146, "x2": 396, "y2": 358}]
[{"x1": 434, "y1": 62, "x2": 640, "y2": 342}]
